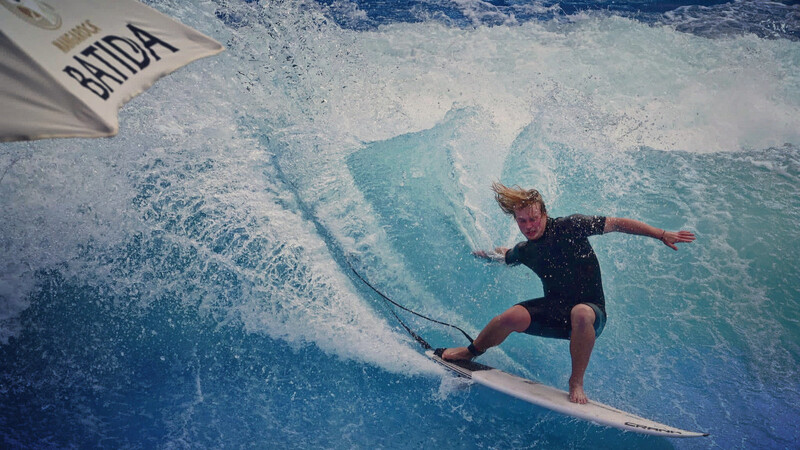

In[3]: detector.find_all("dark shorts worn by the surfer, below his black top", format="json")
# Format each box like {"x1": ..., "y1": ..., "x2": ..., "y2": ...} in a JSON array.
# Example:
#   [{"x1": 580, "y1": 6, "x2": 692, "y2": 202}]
[{"x1": 517, "y1": 297, "x2": 607, "y2": 339}]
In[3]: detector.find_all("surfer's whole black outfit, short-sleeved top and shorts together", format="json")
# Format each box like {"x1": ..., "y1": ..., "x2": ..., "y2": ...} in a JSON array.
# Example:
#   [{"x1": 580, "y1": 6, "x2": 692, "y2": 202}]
[{"x1": 505, "y1": 214, "x2": 606, "y2": 338}]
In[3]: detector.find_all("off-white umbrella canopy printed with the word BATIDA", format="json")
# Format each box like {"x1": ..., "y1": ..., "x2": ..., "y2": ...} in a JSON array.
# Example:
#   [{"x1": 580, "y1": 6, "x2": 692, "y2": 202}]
[{"x1": 0, "y1": 0, "x2": 223, "y2": 141}]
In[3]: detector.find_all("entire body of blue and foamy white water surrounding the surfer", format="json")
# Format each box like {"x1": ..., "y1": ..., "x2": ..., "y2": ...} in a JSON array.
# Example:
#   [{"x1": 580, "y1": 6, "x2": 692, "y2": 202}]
[{"x1": 0, "y1": 0, "x2": 800, "y2": 449}]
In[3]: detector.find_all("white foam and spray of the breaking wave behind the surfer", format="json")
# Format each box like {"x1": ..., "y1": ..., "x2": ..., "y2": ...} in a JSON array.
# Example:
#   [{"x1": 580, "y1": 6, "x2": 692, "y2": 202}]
[{"x1": 0, "y1": 2, "x2": 800, "y2": 380}]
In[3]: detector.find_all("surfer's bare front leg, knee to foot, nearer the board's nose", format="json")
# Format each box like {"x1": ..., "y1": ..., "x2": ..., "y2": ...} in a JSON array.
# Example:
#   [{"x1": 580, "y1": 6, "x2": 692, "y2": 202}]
[{"x1": 569, "y1": 304, "x2": 596, "y2": 404}]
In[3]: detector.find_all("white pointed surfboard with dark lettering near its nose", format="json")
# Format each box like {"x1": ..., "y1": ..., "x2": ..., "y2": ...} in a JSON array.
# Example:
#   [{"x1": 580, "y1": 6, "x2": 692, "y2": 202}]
[{"x1": 425, "y1": 350, "x2": 708, "y2": 437}]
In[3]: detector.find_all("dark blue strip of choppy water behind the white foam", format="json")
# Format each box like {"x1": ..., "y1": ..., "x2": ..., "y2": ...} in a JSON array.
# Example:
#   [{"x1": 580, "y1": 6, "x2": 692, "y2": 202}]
[{"x1": 317, "y1": 0, "x2": 800, "y2": 41}]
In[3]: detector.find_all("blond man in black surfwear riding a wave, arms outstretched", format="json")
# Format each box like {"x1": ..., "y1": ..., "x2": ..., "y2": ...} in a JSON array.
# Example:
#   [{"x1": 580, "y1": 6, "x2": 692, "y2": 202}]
[{"x1": 442, "y1": 183, "x2": 695, "y2": 404}]
